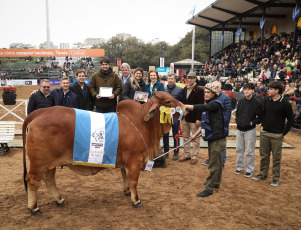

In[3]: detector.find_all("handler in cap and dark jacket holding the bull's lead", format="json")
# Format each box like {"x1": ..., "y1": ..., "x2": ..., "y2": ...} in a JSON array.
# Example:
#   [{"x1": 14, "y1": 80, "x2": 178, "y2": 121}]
[{"x1": 186, "y1": 83, "x2": 229, "y2": 197}]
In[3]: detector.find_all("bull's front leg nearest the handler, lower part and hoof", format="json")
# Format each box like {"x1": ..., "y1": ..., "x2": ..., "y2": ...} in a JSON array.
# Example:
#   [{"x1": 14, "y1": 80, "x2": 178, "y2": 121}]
[{"x1": 126, "y1": 162, "x2": 143, "y2": 208}]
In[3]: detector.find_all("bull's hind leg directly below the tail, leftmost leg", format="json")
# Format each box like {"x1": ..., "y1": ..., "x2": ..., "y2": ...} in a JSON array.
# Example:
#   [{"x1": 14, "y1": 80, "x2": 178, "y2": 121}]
[{"x1": 26, "y1": 170, "x2": 42, "y2": 215}]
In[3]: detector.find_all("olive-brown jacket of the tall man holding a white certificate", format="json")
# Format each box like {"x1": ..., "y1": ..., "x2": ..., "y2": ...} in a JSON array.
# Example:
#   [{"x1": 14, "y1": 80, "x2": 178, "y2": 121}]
[{"x1": 89, "y1": 68, "x2": 121, "y2": 108}]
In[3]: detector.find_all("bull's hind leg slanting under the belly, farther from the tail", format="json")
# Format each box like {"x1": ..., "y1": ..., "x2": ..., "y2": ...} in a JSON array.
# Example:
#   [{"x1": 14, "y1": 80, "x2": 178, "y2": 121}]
[{"x1": 43, "y1": 168, "x2": 65, "y2": 207}]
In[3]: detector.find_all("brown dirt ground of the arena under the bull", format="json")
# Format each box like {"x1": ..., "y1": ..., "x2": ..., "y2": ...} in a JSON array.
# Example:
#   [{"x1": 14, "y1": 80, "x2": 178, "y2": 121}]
[{"x1": 0, "y1": 87, "x2": 301, "y2": 230}]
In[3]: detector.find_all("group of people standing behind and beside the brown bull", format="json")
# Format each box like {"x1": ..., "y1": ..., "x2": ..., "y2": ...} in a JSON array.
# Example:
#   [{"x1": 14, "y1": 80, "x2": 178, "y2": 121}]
[{"x1": 28, "y1": 58, "x2": 293, "y2": 197}]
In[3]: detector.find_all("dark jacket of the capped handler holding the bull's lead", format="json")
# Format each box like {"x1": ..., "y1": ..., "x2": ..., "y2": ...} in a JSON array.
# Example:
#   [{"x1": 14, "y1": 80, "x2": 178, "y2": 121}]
[{"x1": 193, "y1": 97, "x2": 224, "y2": 141}]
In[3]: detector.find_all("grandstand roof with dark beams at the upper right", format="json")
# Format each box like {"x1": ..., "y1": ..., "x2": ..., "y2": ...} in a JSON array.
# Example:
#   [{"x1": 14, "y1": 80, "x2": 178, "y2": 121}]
[{"x1": 186, "y1": 0, "x2": 296, "y2": 30}]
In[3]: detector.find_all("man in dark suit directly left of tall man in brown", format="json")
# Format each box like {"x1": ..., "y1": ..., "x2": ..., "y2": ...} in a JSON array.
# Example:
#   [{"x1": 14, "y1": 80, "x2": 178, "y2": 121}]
[{"x1": 69, "y1": 70, "x2": 94, "y2": 111}]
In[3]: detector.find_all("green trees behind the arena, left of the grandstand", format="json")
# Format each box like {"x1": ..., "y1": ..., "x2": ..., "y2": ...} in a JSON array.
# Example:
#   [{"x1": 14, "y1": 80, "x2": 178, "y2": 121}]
[{"x1": 92, "y1": 28, "x2": 209, "y2": 70}]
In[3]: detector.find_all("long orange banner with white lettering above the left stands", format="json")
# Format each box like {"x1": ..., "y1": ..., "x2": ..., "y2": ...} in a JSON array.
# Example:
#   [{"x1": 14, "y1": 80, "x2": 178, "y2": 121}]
[{"x1": 0, "y1": 49, "x2": 105, "y2": 57}]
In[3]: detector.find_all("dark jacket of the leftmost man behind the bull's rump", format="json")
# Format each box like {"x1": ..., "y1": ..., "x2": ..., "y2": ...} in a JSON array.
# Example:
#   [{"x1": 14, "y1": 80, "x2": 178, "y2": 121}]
[{"x1": 27, "y1": 90, "x2": 54, "y2": 115}]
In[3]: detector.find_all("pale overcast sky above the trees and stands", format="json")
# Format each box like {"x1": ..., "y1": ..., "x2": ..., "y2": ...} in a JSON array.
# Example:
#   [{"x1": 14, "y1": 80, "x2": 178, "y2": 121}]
[{"x1": 0, "y1": 0, "x2": 215, "y2": 48}]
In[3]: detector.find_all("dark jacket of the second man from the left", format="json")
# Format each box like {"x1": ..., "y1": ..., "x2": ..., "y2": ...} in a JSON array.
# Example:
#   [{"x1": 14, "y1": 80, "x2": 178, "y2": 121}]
[{"x1": 51, "y1": 88, "x2": 78, "y2": 108}]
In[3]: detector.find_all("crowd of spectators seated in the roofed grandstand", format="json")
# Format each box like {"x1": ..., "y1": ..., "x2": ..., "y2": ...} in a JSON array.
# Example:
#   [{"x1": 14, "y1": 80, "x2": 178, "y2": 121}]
[{"x1": 186, "y1": 33, "x2": 301, "y2": 90}]
